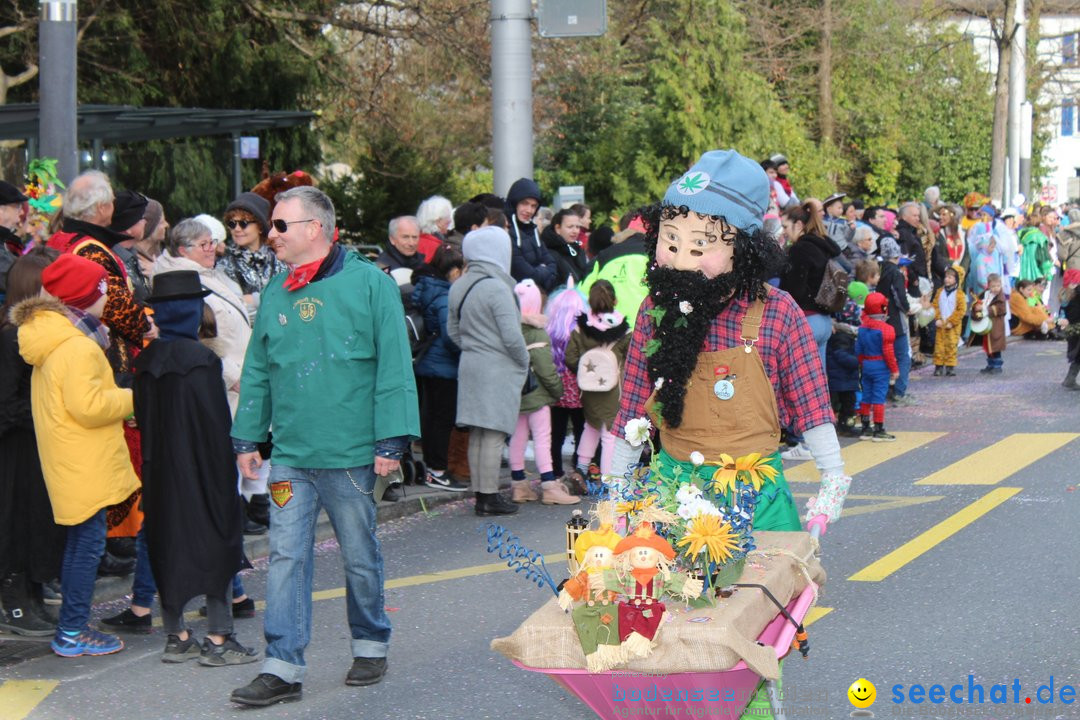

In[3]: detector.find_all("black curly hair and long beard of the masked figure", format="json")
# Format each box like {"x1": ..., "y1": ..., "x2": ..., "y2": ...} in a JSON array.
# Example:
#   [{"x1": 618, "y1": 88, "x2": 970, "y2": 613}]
[{"x1": 640, "y1": 203, "x2": 787, "y2": 427}]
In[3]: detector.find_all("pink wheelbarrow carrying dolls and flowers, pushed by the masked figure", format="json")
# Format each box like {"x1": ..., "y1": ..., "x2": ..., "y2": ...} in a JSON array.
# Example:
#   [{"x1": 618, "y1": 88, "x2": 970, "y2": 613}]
[{"x1": 512, "y1": 516, "x2": 825, "y2": 720}]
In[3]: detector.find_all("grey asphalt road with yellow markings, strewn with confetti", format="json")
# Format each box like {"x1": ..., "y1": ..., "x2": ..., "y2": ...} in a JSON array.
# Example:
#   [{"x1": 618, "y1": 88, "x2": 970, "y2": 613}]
[{"x1": 0, "y1": 342, "x2": 1080, "y2": 720}]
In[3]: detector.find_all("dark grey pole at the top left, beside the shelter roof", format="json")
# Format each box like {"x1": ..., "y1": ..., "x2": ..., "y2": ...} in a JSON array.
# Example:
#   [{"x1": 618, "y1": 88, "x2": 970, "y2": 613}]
[{"x1": 38, "y1": 0, "x2": 79, "y2": 184}]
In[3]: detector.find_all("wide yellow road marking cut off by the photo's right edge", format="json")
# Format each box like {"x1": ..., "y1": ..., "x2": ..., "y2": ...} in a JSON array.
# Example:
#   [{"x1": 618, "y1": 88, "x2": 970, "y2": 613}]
[{"x1": 916, "y1": 433, "x2": 1080, "y2": 485}]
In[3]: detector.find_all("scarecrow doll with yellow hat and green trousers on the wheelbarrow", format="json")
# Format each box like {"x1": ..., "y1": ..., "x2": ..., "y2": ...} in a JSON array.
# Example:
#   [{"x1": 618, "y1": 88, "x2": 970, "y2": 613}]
[{"x1": 558, "y1": 524, "x2": 625, "y2": 673}]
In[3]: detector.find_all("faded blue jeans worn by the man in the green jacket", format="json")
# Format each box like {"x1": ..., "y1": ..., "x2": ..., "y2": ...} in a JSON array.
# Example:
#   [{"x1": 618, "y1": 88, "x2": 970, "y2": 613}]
[{"x1": 262, "y1": 464, "x2": 390, "y2": 682}]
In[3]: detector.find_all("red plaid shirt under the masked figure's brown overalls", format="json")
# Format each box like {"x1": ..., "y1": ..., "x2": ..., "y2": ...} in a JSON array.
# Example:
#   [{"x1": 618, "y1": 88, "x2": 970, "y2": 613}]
[{"x1": 612, "y1": 289, "x2": 833, "y2": 437}]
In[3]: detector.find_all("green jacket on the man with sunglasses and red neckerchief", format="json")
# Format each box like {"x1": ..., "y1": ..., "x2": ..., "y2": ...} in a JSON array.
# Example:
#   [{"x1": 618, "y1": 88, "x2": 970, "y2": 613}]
[{"x1": 232, "y1": 252, "x2": 420, "y2": 468}]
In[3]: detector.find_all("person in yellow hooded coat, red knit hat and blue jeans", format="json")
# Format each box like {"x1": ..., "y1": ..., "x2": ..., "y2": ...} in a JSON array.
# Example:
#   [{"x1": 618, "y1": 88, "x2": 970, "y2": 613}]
[{"x1": 11, "y1": 254, "x2": 138, "y2": 657}]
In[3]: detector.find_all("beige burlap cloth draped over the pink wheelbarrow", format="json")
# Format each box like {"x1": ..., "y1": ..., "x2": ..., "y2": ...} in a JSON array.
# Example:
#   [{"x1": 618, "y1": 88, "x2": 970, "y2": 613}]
[{"x1": 491, "y1": 531, "x2": 825, "y2": 680}]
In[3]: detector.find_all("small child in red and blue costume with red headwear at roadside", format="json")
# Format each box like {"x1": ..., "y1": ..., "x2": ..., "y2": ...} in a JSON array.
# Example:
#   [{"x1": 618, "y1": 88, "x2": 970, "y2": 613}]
[{"x1": 855, "y1": 293, "x2": 900, "y2": 443}]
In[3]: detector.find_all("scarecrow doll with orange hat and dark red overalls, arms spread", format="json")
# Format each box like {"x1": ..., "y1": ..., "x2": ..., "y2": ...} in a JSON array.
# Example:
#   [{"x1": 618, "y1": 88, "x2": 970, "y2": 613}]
[{"x1": 591, "y1": 522, "x2": 703, "y2": 657}]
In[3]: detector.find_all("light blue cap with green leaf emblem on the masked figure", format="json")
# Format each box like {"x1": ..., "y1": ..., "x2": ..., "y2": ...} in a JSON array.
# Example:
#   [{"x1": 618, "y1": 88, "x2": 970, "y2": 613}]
[{"x1": 664, "y1": 150, "x2": 769, "y2": 233}]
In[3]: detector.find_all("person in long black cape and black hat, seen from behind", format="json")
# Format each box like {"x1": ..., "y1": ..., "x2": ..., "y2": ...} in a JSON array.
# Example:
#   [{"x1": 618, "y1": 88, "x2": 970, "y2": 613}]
[{"x1": 135, "y1": 270, "x2": 258, "y2": 666}]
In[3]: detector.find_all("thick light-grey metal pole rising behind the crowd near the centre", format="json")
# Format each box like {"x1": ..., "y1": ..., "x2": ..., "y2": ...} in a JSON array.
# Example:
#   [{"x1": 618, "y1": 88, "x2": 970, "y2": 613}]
[{"x1": 491, "y1": 0, "x2": 532, "y2": 195}]
